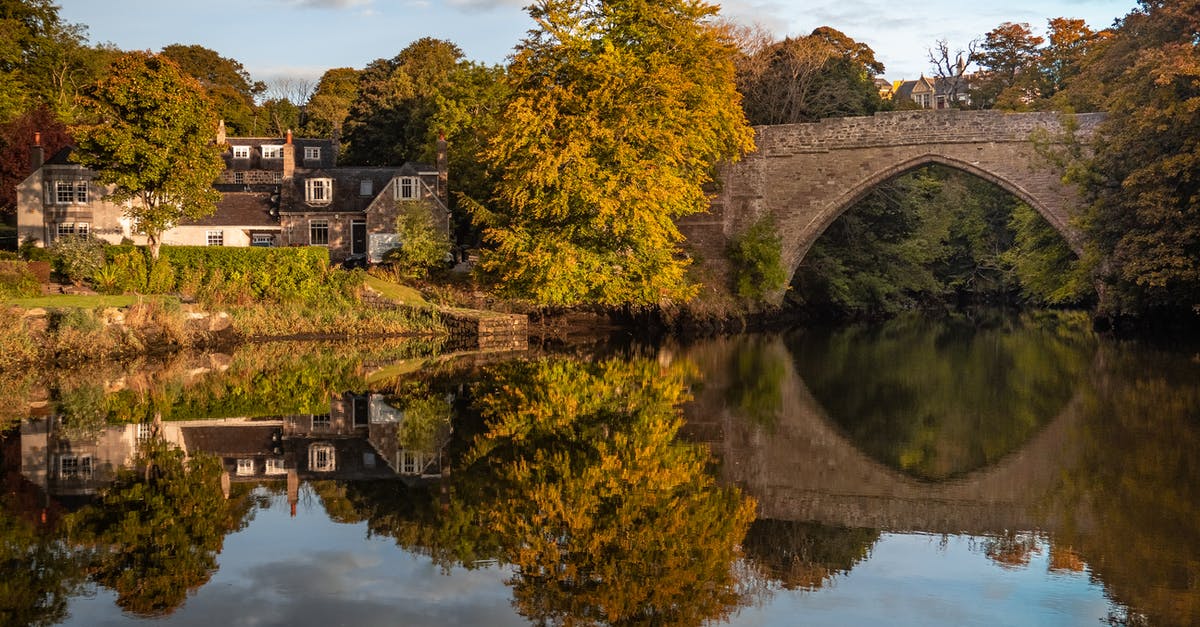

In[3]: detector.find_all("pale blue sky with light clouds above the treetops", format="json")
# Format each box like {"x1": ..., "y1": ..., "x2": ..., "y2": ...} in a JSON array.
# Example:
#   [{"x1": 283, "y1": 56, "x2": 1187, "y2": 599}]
[{"x1": 58, "y1": 0, "x2": 1136, "y2": 84}]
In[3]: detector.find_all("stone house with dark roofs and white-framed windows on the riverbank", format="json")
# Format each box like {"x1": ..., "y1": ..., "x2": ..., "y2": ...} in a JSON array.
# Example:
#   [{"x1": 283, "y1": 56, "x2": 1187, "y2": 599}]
[{"x1": 17, "y1": 124, "x2": 450, "y2": 262}]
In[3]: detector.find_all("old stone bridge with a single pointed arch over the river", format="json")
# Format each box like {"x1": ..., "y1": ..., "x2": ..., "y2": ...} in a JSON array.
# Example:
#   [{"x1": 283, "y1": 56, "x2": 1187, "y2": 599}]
[{"x1": 679, "y1": 111, "x2": 1104, "y2": 288}]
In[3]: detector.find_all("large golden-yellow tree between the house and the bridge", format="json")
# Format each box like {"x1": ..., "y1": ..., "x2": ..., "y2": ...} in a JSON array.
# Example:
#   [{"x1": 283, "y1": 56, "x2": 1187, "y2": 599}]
[{"x1": 473, "y1": 0, "x2": 754, "y2": 305}]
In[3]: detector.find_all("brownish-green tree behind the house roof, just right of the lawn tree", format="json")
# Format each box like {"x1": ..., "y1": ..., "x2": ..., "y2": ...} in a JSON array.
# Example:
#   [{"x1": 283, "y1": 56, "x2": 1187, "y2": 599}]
[{"x1": 162, "y1": 43, "x2": 264, "y2": 135}]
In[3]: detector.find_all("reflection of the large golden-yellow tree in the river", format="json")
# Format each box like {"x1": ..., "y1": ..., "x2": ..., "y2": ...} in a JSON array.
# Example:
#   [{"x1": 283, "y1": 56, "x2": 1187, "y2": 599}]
[{"x1": 354, "y1": 358, "x2": 754, "y2": 625}]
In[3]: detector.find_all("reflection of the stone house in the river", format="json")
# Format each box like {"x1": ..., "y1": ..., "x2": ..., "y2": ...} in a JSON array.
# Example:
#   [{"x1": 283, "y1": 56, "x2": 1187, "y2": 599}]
[{"x1": 20, "y1": 393, "x2": 446, "y2": 512}]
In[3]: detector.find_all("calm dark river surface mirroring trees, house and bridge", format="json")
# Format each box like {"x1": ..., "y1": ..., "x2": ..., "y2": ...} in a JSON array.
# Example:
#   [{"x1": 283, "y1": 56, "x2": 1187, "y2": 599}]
[{"x1": 0, "y1": 314, "x2": 1200, "y2": 626}]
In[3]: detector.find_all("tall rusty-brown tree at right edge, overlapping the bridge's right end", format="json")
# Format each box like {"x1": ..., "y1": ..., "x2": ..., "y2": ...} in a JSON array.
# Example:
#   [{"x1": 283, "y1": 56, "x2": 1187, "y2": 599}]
[{"x1": 1064, "y1": 0, "x2": 1200, "y2": 314}]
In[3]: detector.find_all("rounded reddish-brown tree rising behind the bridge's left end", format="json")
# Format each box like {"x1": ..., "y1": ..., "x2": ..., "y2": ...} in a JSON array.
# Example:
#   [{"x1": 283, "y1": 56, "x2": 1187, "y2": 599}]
[{"x1": 738, "y1": 26, "x2": 883, "y2": 124}]
